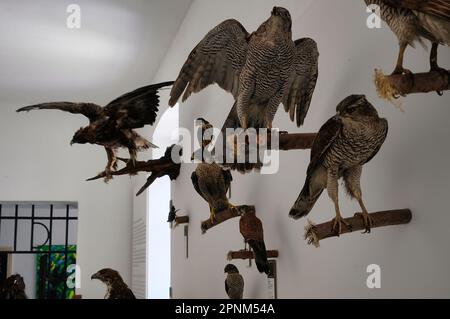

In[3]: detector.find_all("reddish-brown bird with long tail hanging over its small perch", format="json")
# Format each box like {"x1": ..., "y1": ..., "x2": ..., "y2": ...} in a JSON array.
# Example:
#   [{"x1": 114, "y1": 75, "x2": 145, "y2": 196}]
[{"x1": 239, "y1": 209, "x2": 270, "y2": 275}]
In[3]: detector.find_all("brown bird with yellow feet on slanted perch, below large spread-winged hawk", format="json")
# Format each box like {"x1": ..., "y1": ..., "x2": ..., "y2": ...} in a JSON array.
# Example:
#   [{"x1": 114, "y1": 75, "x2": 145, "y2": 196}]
[{"x1": 191, "y1": 163, "x2": 235, "y2": 222}]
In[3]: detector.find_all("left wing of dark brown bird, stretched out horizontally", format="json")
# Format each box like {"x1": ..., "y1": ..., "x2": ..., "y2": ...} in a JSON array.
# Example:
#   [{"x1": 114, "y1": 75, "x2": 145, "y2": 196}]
[{"x1": 17, "y1": 102, "x2": 102, "y2": 122}]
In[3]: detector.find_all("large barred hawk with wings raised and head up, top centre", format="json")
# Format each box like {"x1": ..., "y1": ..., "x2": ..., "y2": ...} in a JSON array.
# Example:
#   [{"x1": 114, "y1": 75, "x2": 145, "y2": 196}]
[{"x1": 169, "y1": 7, "x2": 319, "y2": 129}]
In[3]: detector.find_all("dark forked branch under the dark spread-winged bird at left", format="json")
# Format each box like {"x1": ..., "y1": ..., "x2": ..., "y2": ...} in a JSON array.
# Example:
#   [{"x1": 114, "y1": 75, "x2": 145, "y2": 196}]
[{"x1": 88, "y1": 145, "x2": 181, "y2": 196}]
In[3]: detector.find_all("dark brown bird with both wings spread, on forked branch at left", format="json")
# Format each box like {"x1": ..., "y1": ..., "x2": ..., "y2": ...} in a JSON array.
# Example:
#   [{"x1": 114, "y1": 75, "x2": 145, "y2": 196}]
[{"x1": 17, "y1": 82, "x2": 173, "y2": 181}]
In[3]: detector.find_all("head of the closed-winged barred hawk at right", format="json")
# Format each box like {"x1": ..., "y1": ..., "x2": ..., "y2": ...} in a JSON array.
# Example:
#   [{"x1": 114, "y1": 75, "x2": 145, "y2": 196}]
[{"x1": 336, "y1": 95, "x2": 378, "y2": 120}]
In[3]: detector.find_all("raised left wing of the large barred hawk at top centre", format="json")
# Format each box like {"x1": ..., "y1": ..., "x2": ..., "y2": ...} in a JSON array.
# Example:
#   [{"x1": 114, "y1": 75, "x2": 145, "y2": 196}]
[{"x1": 169, "y1": 19, "x2": 249, "y2": 106}]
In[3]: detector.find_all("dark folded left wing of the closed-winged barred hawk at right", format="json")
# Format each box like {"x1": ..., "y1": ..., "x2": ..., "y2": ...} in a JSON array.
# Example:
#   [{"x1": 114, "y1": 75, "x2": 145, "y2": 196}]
[{"x1": 307, "y1": 116, "x2": 342, "y2": 175}]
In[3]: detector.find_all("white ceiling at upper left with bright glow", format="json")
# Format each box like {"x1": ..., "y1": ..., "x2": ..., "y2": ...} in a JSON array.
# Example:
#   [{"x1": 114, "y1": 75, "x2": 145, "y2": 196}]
[{"x1": 0, "y1": 0, "x2": 192, "y2": 103}]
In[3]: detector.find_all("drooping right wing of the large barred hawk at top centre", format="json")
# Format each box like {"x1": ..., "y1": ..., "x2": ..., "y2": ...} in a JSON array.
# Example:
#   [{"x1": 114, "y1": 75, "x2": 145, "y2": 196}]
[{"x1": 283, "y1": 38, "x2": 319, "y2": 126}]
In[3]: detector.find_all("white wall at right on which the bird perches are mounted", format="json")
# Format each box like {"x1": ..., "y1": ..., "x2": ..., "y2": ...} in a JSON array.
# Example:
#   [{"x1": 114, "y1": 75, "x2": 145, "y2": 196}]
[{"x1": 153, "y1": 0, "x2": 450, "y2": 298}]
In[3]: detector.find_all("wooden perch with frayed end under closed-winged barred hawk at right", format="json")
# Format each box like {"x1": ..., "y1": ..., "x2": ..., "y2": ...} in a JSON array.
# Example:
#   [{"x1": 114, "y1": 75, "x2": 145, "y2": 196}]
[{"x1": 305, "y1": 209, "x2": 412, "y2": 247}]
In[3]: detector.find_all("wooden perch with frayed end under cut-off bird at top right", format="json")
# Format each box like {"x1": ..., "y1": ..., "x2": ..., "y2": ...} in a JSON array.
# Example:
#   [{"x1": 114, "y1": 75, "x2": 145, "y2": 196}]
[{"x1": 375, "y1": 69, "x2": 450, "y2": 101}]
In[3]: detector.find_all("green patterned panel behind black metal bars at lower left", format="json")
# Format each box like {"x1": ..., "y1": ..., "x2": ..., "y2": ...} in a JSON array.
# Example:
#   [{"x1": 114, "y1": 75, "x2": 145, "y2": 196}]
[{"x1": 36, "y1": 245, "x2": 77, "y2": 299}]
